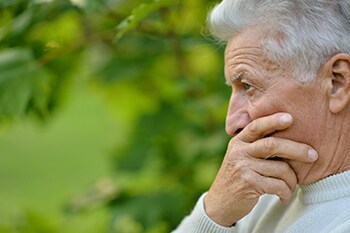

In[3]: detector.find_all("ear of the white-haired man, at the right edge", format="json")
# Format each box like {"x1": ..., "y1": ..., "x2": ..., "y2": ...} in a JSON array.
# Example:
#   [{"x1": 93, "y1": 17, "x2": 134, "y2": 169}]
[{"x1": 325, "y1": 53, "x2": 350, "y2": 113}]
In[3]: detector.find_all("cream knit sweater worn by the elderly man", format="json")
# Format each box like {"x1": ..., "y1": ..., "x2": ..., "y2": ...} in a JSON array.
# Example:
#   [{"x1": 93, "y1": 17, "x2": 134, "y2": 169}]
[{"x1": 173, "y1": 171, "x2": 350, "y2": 233}]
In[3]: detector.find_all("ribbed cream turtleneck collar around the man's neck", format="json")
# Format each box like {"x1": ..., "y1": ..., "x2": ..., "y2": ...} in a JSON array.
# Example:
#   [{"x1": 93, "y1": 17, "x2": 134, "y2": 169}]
[{"x1": 299, "y1": 171, "x2": 350, "y2": 204}]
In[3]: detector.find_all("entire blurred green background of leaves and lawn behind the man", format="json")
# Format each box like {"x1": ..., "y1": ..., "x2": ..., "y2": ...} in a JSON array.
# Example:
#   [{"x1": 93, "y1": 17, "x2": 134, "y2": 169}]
[{"x1": 0, "y1": 0, "x2": 230, "y2": 233}]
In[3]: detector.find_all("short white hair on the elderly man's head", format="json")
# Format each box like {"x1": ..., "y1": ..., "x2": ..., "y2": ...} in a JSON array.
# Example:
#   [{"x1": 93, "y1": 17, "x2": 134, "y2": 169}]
[{"x1": 208, "y1": 0, "x2": 350, "y2": 82}]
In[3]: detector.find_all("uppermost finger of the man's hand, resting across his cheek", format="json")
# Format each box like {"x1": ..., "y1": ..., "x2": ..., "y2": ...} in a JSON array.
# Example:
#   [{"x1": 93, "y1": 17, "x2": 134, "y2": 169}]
[{"x1": 236, "y1": 113, "x2": 293, "y2": 143}]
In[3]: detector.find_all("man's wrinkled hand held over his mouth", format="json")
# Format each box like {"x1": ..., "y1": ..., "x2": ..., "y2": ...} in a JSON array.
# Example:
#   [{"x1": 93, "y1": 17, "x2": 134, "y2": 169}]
[{"x1": 204, "y1": 113, "x2": 317, "y2": 226}]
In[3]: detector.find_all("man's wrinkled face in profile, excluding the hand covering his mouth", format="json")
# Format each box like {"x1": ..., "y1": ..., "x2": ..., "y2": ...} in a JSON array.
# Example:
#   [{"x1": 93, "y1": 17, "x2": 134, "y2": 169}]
[{"x1": 225, "y1": 27, "x2": 327, "y2": 183}]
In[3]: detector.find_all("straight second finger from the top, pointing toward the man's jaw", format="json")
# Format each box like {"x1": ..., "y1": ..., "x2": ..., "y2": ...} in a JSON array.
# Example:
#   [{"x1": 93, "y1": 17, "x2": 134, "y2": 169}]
[{"x1": 247, "y1": 137, "x2": 318, "y2": 163}]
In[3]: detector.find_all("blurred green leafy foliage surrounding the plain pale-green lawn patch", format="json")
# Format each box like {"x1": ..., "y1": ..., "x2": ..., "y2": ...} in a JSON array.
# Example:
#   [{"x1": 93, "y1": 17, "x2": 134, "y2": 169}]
[{"x1": 0, "y1": 0, "x2": 229, "y2": 233}]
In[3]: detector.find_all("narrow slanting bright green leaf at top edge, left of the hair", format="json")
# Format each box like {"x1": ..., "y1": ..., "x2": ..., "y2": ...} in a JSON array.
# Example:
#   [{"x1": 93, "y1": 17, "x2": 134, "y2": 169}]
[{"x1": 116, "y1": 0, "x2": 177, "y2": 40}]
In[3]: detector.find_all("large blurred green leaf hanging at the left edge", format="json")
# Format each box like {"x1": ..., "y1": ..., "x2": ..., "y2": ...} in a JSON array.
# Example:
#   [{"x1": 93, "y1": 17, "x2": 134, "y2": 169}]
[{"x1": 0, "y1": 48, "x2": 52, "y2": 118}]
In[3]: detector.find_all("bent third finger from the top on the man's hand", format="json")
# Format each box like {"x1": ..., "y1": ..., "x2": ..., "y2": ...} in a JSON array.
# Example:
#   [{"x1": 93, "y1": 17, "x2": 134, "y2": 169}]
[{"x1": 253, "y1": 159, "x2": 297, "y2": 192}]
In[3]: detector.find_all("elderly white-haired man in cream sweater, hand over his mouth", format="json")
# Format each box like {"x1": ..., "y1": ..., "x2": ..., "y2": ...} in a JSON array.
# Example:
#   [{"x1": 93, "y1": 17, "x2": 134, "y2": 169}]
[{"x1": 174, "y1": 0, "x2": 350, "y2": 233}]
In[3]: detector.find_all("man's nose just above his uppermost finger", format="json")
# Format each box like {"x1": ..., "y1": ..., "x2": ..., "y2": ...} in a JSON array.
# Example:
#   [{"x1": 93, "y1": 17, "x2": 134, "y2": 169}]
[{"x1": 226, "y1": 93, "x2": 252, "y2": 136}]
